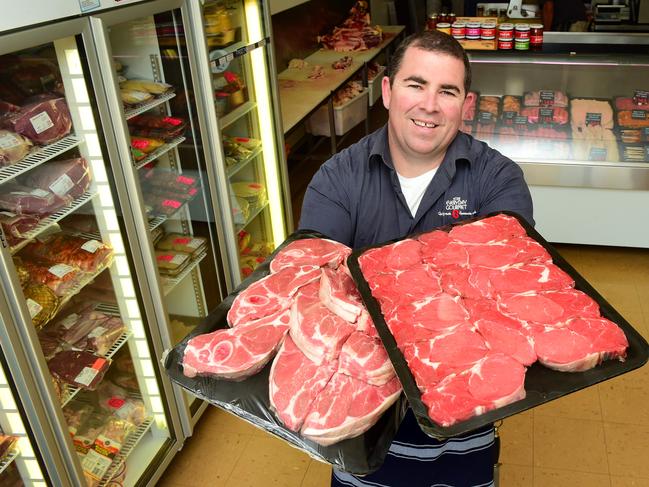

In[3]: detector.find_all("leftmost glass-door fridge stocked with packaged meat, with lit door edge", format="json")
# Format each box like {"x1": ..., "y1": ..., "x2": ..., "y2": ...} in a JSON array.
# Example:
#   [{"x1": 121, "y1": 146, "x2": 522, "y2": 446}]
[{"x1": 0, "y1": 18, "x2": 183, "y2": 486}]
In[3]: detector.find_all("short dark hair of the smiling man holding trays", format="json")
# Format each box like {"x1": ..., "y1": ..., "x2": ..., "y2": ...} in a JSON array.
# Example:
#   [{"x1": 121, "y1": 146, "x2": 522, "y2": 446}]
[{"x1": 388, "y1": 30, "x2": 471, "y2": 94}]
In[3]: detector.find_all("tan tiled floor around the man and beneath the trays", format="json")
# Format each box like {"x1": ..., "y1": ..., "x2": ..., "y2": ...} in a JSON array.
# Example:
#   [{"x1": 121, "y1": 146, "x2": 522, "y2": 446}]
[{"x1": 159, "y1": 245, "x2": 649, "y2": 487}]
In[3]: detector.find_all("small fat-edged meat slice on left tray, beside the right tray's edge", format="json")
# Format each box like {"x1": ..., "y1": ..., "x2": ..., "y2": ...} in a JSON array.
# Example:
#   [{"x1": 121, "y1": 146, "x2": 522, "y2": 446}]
[{"x1": 320, "y1": 267, "x2": 363, "y2": 323}]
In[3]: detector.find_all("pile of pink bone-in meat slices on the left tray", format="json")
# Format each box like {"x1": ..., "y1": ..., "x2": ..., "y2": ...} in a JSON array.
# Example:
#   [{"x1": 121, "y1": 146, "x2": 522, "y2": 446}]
[{"x1": 183, "y1": 239, "x2": 401, "y2": 446}]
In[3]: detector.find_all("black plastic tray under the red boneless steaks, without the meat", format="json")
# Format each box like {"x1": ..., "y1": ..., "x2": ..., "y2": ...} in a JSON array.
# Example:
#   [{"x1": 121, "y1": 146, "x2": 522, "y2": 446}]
[{"x1": 347, "y1": 211, "x2": 649, "y2": 439}]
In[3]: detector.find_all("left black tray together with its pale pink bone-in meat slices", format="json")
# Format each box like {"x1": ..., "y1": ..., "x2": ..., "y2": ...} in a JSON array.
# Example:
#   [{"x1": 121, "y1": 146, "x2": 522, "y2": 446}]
[{"x1": 165, "y1": 231, "x2": 405, "y2": 474}]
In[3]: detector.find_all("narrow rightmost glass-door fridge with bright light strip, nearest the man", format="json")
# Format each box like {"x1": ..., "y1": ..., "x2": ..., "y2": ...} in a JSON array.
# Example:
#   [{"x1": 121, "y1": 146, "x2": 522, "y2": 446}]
[{"x1": 187, "y1": 0, "x2": 293, "y2": 286}]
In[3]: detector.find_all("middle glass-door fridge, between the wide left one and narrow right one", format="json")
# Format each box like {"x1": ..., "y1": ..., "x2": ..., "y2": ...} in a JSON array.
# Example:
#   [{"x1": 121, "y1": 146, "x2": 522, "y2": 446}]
[{"x1": 85, "y1": 0, "x2": 231, "y2": 436}]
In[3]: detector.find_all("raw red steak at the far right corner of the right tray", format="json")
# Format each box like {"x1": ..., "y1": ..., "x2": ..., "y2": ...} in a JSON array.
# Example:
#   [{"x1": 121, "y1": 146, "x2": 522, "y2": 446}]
[{"x1": 533, "y1": 318, "x2": 629, "y2": 372}]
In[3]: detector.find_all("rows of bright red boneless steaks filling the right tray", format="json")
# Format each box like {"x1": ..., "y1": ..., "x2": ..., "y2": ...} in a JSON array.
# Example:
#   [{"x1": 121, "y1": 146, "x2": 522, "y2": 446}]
[{"x1": 359, "y1": 215, "x2": 628, "y2": 426}]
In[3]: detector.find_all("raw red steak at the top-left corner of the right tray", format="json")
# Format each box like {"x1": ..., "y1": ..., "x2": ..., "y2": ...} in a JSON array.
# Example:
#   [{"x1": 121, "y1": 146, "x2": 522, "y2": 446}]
[{"x1": 358, "y1": 238, "x2": 421, "y2": 276}]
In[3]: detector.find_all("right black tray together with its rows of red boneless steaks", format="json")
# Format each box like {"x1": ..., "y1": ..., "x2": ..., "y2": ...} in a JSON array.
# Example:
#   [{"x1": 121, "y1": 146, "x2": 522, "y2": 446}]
[{"x1": 348, "y1": 213, "x2": 649, "y2": 438}]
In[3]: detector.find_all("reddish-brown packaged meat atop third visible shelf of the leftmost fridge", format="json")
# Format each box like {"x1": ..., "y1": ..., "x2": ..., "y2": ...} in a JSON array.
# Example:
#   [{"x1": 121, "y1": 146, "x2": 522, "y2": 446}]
[{"x1": 22, "y1": 232, "x2": 113, "y2": 273}]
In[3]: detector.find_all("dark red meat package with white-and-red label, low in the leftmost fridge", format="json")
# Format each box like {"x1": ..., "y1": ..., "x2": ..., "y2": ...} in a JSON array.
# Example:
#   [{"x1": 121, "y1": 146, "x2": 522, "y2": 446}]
[{"x1": 47, "y1": 350, "x2": 110, "y2": 391}]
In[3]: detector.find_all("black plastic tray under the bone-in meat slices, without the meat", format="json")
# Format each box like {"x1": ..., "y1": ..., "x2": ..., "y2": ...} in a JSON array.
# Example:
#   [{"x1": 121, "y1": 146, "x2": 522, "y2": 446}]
[{"x1": 163, "y1": 230, "x2": 407, "y2": 475}]
